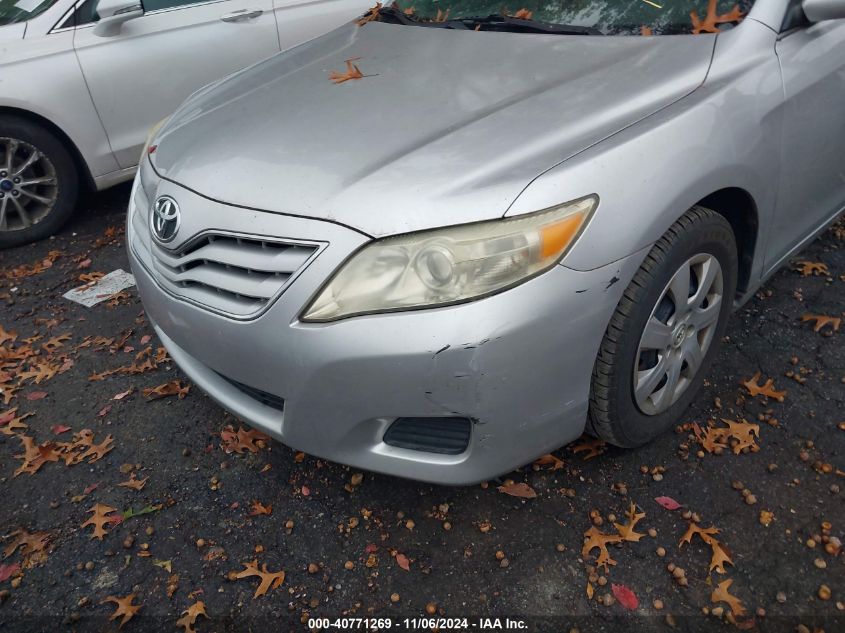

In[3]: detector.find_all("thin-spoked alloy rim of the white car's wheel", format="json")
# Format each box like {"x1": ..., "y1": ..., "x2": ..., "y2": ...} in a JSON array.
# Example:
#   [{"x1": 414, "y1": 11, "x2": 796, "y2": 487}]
[{"x1": 0, "y1": 137, "x2": 59, "y2": 231}]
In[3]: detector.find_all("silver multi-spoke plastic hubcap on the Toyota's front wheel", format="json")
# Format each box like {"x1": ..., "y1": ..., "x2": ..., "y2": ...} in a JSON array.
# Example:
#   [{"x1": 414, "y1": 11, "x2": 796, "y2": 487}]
[{"x1": 634, "y1": 253, "x2": 724, "y2": 415}]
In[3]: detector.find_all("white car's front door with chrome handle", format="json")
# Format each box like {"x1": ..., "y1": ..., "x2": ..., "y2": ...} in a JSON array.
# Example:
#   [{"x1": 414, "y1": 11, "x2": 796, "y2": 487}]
[{"x1": 74, "y1": 0, "x2": 279, "y2": 168}]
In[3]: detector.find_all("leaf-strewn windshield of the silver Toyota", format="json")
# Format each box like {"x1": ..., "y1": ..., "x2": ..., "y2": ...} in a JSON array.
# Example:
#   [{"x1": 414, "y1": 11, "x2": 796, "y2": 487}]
[{"x1": 381, "y1": 0, "x2": 754, "y2": 35}]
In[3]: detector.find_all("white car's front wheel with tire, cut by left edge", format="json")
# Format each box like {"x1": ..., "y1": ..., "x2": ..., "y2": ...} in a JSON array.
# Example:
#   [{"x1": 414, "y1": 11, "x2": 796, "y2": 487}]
[{"x1": 0, "y1": 117, "x2": 79, "y2": 248}]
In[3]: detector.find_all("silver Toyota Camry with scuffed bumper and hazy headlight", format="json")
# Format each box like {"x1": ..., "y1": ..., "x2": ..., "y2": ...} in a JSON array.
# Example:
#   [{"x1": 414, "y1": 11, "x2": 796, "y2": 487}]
[{"x1": 127, "y1": 0, "x2": 845, "y2": 484}]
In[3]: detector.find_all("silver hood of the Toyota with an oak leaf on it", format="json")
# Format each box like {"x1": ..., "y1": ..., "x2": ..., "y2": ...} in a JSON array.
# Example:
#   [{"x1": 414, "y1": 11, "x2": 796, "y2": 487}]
[{"x1": 153, "y1": 23, "x2": 715, "y2": 237}]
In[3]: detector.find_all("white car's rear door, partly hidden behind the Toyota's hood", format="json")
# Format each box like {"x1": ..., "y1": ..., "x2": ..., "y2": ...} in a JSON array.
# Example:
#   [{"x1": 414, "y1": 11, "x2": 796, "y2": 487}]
[{"x1": 273, "y1": 0, "x2": 375, "y2": 51}]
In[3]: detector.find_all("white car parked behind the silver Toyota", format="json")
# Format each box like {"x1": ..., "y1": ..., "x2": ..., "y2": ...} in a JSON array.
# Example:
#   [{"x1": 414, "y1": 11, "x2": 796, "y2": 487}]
[{"x1": 0, "y1": 0, "x2": 373, "y2": 248}]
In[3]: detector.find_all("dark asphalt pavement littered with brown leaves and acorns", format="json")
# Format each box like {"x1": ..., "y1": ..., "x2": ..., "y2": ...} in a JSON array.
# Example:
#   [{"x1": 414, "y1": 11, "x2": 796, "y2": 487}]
[{"x1": 0, "y1": 186, "x2": 845, "y2": 633}]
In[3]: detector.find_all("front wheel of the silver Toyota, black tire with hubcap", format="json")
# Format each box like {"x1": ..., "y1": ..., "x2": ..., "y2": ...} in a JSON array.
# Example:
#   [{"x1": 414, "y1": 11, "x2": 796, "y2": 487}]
[{"x1": 588, "y1": 207, "x2": 737, "y2": 447}]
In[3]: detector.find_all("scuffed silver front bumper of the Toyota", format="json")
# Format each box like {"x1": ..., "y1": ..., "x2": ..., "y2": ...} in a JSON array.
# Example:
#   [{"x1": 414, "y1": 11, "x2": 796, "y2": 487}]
[{"x1": 127, "y1": 175, "x2": 644, "y2": 484}]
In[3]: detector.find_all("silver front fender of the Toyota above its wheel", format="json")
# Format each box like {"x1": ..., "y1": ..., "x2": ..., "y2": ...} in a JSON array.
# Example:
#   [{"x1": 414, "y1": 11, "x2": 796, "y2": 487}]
[{"x1": 507, "y1": 21, "x2": 782, "y2": 279}]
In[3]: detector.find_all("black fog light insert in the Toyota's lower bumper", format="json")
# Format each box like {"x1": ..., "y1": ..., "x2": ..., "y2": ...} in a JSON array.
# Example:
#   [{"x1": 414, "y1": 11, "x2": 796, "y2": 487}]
[{"x1": 382, "y1": 418, "x2": 472, "y2": 455}]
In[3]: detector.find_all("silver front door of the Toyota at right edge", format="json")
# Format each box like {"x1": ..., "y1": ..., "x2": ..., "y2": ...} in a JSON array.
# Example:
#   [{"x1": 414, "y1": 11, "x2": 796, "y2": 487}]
[{"x1": 766, "y1": 14, "x2": 845, "y2": 267}]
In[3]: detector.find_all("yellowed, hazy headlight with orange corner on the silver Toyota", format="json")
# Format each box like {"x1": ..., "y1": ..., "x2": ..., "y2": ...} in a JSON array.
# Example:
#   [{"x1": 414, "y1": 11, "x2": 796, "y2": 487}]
[{"x1": 302, "y1": 195, "x2": 598, "y2": 321}]
